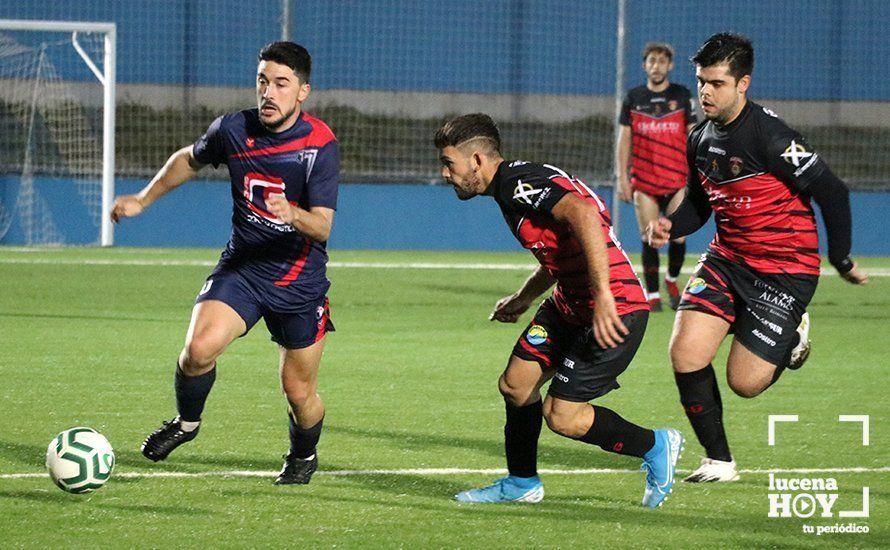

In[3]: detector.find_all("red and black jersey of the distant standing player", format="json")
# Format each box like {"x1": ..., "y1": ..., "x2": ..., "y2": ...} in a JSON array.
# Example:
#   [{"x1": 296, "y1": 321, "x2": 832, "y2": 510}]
[{"x1": 618, "y1": 84, "x2": 696, "y2": 197}]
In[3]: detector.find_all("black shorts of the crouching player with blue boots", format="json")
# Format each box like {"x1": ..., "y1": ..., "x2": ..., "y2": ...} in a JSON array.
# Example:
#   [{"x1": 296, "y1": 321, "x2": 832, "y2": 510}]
[{"x1": 513, "y1": 298, "x2": 649, "y2": 403}]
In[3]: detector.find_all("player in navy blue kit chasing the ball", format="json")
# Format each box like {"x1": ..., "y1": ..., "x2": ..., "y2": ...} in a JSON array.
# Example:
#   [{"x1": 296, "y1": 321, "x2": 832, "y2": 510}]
[{"x1": 111, "y1": 42, "x2": 340, "y2": 484}]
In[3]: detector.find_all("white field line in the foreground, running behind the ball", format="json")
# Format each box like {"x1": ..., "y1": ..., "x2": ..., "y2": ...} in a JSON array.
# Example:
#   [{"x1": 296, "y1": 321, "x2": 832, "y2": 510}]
[{"x1": 0, "y1": 466, "x2": 890, "y2": 479}]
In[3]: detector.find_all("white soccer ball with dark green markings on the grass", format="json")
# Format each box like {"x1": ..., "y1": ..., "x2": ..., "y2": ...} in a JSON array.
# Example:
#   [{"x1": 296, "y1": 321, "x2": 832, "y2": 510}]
[{"x1": 46, "y1": 428, "x2": 114, "y2": 493}]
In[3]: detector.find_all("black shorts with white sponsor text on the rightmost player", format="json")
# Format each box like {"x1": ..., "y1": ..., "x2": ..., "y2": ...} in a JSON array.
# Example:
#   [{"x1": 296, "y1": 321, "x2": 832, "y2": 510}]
[{"x1": 678, "y1": 252, "x2": 819, "y2": 365}]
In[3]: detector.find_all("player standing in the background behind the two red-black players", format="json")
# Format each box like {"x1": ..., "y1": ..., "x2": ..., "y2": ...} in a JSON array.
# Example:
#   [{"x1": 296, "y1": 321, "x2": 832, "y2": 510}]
[{"x1": 616, "y1": 42, "x2": 696, "y2": 311}]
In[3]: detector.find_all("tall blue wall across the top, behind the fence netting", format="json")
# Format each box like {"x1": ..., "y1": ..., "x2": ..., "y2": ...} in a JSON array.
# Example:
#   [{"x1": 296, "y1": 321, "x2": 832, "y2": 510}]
[{"x1": 0, "y1": 0, "x2": 890, "y2": 100}]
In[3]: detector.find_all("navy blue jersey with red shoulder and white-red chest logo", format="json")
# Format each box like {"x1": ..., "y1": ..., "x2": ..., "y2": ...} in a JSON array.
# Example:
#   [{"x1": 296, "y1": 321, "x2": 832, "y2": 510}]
[{"x1": 194, "y1": 109, "x2": 340, "y2": 301}]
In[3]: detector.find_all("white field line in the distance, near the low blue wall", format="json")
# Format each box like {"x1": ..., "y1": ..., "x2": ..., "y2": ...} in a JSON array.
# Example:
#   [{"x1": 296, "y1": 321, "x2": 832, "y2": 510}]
[{"x1": 0, "y1": 256, "x2": 890, "y2": 277}]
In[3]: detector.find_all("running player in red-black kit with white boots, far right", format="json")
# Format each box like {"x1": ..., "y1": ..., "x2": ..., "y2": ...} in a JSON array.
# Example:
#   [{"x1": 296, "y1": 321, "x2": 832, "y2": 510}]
[{"x1": 649, "y1": 33, "x2": 868, "y2": 482}]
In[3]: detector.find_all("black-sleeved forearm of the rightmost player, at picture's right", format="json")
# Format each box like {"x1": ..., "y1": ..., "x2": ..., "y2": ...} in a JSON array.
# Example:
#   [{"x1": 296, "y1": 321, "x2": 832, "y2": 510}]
[{"x1": 807, "y1": 169, "x2": 853, "y2": 273}]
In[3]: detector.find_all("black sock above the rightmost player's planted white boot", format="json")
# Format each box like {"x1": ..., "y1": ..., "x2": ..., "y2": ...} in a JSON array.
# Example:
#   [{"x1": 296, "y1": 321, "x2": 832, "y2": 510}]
[{"x1": 674, "y1": 364, "x2": 732, "y2": 462}]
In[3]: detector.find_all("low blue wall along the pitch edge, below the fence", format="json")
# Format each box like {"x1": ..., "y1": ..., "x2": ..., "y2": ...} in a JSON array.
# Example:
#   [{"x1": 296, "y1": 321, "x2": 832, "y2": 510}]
[{"x1": 0, "y1": 178, "x2": 890, "y2": 256}]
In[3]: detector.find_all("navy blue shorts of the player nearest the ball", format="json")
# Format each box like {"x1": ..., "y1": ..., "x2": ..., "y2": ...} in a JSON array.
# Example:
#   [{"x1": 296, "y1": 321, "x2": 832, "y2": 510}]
[{"x1": 195, "y1": 267, "x2": 335, "y2": 349}]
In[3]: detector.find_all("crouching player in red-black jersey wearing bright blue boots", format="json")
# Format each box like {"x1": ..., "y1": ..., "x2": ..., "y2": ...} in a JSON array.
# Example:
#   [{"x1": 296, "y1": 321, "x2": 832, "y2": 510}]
[{"x1": 435, "y1": 114, "x2": 683, "y2": 508}]
